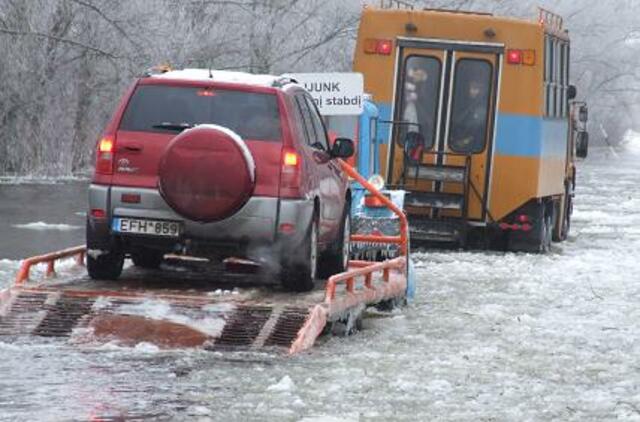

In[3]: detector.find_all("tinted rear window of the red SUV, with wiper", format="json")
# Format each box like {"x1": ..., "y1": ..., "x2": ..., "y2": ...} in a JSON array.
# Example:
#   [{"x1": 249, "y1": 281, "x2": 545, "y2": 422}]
[{"x1": 120, "y1": 85, "x2": 281, "y2": 141}]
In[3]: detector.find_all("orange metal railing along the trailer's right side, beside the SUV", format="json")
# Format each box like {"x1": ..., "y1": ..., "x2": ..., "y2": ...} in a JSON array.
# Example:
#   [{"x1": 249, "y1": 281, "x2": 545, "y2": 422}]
[{"x1": 325, "y1": 160, "x2": 409, "y2": 304}]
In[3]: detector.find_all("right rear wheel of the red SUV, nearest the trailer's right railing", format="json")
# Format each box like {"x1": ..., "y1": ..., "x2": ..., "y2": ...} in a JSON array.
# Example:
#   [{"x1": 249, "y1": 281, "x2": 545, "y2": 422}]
[{"x1": 280, "y1": 215, "x2": 319, "y2": 292}]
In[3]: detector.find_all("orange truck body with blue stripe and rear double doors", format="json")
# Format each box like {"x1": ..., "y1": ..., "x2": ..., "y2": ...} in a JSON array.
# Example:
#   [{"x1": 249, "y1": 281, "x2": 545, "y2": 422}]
[{"x1": 353, "y1": 7, "x2": 575, "y2": 251}]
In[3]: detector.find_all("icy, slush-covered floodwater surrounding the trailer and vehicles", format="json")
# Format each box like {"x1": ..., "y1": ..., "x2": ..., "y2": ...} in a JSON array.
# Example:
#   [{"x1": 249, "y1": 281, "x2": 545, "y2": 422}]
[{"x1": 0, "y1": 151, "x2": 640, "y2": 421}]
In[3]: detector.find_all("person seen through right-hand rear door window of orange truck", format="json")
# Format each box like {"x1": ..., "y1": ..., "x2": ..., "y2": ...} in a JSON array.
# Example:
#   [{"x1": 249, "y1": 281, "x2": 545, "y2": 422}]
[{"x1": 449, "y1": 79, "x2": 488, "y2": 153}]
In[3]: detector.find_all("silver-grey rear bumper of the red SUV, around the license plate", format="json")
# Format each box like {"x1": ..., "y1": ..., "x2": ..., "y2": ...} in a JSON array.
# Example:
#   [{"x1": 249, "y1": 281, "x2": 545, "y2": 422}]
[{"x1": 87, "y1": 184, "x2": 313, "y2": 253}]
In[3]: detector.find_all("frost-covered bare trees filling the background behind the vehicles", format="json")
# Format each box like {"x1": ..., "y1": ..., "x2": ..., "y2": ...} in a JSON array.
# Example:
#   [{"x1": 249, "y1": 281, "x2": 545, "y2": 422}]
[{"x1": 0, "y1": 0, "x2": 640, "y2": 175}]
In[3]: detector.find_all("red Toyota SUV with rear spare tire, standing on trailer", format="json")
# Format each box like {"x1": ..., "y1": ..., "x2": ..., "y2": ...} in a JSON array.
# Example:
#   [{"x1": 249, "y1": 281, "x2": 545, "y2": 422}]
[{"x1": 87, "y1": 69, "x2": 353, "y2": 291}]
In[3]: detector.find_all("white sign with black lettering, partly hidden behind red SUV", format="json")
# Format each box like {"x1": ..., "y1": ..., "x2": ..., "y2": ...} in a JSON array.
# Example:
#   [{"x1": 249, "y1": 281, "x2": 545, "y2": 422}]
[{"x1": 287, "y1": 73, "x2": 364, "y2": 116}]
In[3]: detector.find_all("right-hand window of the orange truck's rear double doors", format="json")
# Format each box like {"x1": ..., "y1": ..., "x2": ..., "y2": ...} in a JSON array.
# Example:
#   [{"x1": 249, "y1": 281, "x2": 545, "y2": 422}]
[{"x1": 448, "y1": 59, "x2": 493, "y2": 154}]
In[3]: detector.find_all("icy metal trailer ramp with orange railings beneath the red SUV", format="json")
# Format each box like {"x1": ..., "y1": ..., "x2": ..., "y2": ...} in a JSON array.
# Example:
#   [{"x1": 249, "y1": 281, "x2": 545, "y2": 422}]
[{"x1": 0, "y1": 160, "x2": 409, "y2": 354}]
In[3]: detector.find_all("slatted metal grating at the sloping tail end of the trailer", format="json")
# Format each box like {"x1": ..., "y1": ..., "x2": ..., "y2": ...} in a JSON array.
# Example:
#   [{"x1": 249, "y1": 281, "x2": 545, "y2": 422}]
[{"x1": 0, "y1": 289, "x2": 320, "y2": 351}]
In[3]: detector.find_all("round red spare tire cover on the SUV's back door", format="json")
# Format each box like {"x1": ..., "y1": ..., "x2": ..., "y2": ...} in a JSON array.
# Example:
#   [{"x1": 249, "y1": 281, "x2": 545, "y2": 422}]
[{"x1": 158, "y1": 125, "x2": 255, "y2": 223}]
